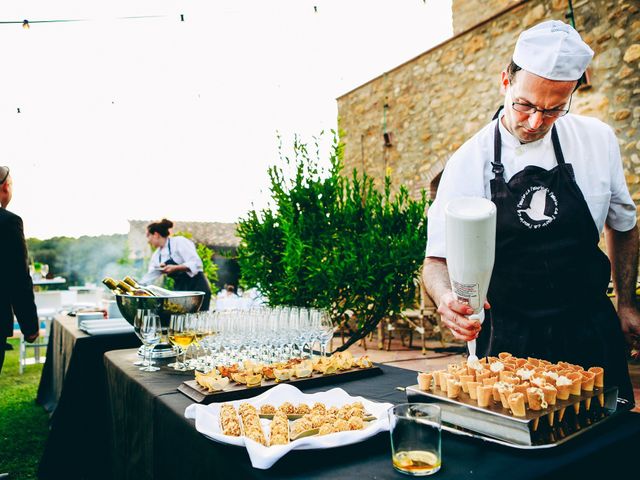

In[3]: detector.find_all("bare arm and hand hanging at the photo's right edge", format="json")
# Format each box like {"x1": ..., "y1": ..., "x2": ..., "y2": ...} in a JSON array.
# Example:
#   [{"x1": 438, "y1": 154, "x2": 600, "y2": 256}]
[{"x1": 604, "y1": 225, "x2": 640, "y2": 341}]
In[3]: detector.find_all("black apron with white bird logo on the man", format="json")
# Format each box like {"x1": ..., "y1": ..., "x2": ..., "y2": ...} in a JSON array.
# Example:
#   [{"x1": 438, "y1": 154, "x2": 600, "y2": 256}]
[{"x1": 477, "y1": 119, "x2": 633, "y2": 402}]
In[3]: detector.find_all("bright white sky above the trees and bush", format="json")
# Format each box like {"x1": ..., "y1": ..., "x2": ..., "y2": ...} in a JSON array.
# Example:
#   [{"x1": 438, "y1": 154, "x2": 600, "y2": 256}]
[{"x1": 0, "y1": 0, "x2": 452, "y2": 238}]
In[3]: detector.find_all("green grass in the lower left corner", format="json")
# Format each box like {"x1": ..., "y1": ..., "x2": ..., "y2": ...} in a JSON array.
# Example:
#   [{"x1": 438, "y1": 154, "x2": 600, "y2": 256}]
[{"x1": 0, "y1": 339, "x2": 49, "y2": 480}]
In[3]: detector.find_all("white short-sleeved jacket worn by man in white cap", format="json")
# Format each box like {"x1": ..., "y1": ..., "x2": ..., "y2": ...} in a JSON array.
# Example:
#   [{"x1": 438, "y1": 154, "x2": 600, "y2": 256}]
[{"x1": 426, "y1": 114, "x2": 636, "y2": 258}]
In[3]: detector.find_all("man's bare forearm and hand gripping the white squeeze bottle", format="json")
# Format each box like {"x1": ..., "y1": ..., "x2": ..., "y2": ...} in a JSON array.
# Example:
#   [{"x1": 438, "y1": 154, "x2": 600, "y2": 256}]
[{"x1": 422, "y1": 257, "x2": 480, "y2": 342}]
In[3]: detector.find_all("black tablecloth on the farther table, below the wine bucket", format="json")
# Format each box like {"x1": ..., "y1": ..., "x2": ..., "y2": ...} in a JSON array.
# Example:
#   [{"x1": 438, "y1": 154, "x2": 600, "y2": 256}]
[{"x1": 36, "y1": 315, "x2": 140, "y2": 479}]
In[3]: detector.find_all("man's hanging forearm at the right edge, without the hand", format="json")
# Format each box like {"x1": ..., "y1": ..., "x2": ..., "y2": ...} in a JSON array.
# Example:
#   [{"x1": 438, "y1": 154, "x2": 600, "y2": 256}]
[{"x1": 604, "y1": 225, "x2": 639, "y2": 308}]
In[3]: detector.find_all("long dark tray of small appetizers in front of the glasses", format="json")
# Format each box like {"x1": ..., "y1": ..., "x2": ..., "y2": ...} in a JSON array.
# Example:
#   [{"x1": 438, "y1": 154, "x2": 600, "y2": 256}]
[{"x1": 178, "y1": 352, "x2": 382, "y2": 404}]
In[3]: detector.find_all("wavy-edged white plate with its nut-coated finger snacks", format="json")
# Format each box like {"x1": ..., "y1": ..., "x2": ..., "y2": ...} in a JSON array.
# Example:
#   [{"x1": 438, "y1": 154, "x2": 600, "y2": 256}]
[{"x1": 185, "y1": 384, "x2": 392, "y2": 469}]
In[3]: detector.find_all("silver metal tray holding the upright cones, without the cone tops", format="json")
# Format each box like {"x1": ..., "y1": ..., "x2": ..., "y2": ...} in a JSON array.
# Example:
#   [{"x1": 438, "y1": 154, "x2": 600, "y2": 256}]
[{"x1": 405, "y1": 385, "x2": 632, "y2": 449}]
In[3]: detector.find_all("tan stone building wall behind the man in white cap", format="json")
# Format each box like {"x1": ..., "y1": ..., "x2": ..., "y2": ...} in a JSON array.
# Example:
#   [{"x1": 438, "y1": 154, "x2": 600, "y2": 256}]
[{"x1": 338, "y1": 0, "x2": 640, "y2": 212}]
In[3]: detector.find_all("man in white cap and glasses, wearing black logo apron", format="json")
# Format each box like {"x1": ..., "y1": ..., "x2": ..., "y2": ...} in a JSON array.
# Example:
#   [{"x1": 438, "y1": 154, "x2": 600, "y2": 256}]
[{"x1": 423, "y1": 20, "x2": 640, "y2": 402}]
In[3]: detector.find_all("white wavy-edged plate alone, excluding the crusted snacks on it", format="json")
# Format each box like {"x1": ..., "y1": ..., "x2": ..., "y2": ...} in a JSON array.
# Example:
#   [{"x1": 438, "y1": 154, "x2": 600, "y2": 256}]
[{"x1": 184, "y1": 383, "x2": 393, "y2": 470}]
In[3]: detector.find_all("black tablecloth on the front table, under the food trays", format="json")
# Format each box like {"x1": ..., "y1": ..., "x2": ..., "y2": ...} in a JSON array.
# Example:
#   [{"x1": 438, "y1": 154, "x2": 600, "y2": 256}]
[{"x1": 105, "y1": 351, "x2": 640, "y2": 479}]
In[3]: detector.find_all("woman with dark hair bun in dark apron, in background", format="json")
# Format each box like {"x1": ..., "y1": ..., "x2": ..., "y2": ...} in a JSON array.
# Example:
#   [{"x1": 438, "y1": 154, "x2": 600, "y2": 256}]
[{"x1": 142, "y1": 218, "x2": 211, "y2": 311}]
